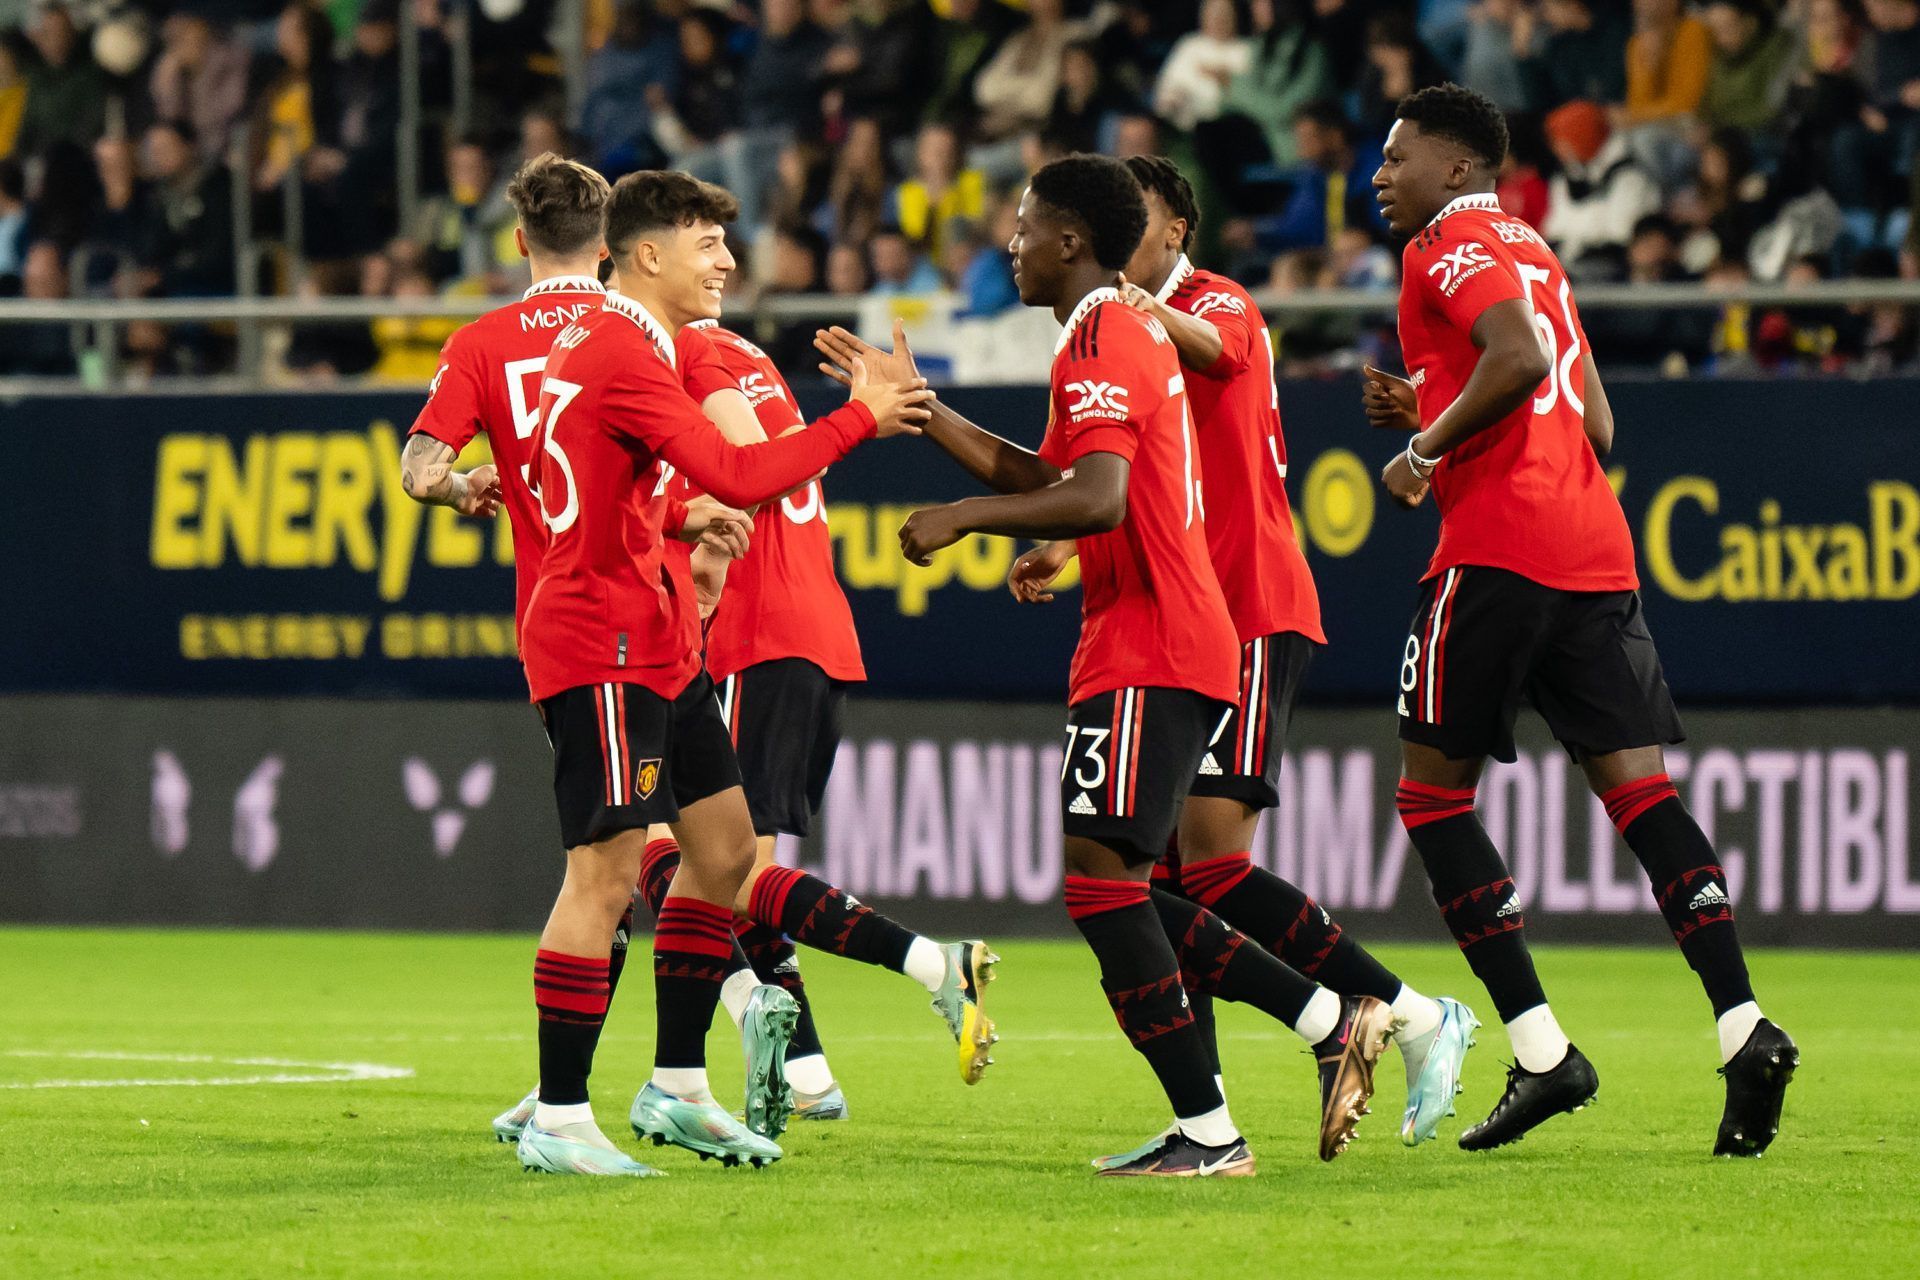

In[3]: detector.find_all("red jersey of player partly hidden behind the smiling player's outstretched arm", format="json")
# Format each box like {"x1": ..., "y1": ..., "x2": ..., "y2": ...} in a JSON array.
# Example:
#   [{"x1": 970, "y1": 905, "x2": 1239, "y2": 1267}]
[{"x1": 670, "y1": 320, "x2": 866, "y2": 681}]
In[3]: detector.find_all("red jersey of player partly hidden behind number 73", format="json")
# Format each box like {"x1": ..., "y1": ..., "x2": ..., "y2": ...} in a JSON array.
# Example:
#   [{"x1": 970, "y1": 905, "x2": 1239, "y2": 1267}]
[{"x1": 1160, "y1": 253, "x2": 1327, "y2": 645}]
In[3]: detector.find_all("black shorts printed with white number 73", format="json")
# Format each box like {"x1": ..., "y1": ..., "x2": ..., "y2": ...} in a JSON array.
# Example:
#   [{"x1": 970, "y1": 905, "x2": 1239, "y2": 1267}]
[{"x1": 1060, "y1": 689, "x2": 1227, "y2": 865}]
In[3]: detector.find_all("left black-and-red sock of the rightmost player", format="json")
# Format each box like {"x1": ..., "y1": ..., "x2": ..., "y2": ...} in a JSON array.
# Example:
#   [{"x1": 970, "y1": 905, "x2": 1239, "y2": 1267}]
[{"x1": 1396, "y1": 777, "x2": 1548, "y2": 1023}]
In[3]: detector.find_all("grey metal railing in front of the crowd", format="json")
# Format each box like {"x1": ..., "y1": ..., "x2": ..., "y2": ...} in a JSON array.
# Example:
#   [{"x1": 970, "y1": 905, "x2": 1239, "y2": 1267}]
[{"x1": 0, "y1": 280, "x2": 1920, "y2": 391}]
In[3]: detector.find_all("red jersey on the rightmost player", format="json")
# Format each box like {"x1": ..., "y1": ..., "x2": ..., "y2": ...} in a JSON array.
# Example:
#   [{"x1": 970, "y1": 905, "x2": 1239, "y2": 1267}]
[{"x1": 1400, "y1": 194, "x2": 1640, "y2": 591}]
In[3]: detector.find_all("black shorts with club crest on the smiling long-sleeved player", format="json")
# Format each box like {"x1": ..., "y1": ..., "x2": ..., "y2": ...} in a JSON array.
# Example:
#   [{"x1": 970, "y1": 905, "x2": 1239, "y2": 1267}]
[{"x1": 540, "y1": 672, "x2": 739, "y2": 848}]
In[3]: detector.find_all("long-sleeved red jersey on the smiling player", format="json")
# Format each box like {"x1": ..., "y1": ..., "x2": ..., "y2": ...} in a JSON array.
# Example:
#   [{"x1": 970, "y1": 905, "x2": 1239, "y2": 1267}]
[{"x1": 520, "y1": 294, "x2": 874, "y2": 702}]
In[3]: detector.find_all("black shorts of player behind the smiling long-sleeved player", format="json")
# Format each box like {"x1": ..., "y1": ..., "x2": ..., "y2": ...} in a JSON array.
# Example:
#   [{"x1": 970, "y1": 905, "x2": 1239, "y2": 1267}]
[{"x1": 720, "y1": 658, "x2": 847, "y2": 835}]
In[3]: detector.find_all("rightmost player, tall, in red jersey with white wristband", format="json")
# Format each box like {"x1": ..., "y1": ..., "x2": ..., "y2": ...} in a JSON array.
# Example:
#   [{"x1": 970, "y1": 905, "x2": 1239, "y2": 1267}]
[{"x1": 1363, "y1": 84, "x2": 1799, "y2": 1155}]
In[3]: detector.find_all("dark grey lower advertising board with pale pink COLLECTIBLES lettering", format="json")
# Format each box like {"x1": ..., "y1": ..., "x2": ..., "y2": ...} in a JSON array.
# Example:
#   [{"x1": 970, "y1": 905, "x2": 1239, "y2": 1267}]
[{"x1": 0, "y1": 695, "x2": 1920, "y2": 948}]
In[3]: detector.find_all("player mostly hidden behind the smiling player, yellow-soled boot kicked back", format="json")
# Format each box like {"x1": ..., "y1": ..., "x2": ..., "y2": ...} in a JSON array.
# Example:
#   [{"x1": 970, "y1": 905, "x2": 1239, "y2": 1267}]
[{"x1": 641, "y1": 312, "x2": 998, "y2": 1119}]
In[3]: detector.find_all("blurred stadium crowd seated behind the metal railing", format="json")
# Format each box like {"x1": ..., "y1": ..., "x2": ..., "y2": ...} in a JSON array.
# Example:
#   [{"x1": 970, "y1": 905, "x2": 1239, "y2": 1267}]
[{"x1": 0, "y1": 0, "x2": 1920, "y2": 384}]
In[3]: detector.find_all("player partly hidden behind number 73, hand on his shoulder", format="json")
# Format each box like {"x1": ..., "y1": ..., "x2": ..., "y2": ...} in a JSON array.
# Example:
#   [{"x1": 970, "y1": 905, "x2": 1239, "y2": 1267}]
[{"x1": 1008, "y1": 155, "x2": 1478, "y2": 1146}]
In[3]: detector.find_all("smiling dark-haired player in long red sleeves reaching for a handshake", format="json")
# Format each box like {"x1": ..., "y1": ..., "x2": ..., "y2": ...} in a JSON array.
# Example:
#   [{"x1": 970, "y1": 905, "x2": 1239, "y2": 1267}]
[{"x1": 518, "y1": 171, "x2": 931, "y2": 1176}]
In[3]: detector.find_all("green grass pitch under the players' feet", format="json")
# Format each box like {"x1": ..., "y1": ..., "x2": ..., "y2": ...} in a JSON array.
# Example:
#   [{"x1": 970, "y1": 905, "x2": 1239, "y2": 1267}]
[{"x1": 0, "y1": 929, "x2": 1920, "y2": 1280}]
